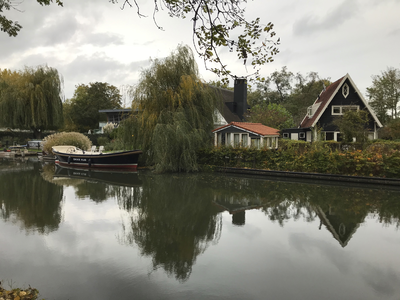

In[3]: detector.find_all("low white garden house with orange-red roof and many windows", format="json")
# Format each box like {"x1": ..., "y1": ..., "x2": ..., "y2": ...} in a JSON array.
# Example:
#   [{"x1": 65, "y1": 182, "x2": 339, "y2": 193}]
[{"x1": 212, "y1": 122, "x2": 279, "y2": 149}]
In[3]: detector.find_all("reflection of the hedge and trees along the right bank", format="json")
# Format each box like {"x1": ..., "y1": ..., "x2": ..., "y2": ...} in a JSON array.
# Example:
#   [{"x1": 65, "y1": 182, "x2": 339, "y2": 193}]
[{"x1": 208, "y1": 176, "x2": 400, "y2": 229}]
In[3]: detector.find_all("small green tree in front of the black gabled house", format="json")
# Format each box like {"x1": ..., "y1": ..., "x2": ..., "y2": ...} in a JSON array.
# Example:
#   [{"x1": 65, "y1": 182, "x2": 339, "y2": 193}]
[{"x1": 334, "y1": 110, "x2": 369, "y2": 143}]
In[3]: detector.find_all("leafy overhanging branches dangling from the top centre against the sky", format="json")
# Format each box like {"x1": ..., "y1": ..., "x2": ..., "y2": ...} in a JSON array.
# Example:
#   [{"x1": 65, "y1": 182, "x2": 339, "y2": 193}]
[{"x1": 111, "y1": 0, "x2": 280, "y2": 78}]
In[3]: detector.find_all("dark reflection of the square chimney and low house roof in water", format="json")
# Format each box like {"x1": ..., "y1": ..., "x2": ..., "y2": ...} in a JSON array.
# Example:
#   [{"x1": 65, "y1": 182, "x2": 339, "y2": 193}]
[{"x1": 214, "y1": 194, "x2": 262, "y2": 226}]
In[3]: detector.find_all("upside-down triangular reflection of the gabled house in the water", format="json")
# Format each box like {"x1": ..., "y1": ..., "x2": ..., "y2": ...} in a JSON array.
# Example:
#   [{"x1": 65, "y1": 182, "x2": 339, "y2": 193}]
[{"x1": 315, "y1": 206, "x2": 365, "y2": 247}]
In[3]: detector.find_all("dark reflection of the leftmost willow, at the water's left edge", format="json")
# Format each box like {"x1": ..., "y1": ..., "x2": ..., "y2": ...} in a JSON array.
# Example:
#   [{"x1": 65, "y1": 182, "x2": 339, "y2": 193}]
[{"x1": 0, "y1": 162, "x2": 63, "y2": 234}]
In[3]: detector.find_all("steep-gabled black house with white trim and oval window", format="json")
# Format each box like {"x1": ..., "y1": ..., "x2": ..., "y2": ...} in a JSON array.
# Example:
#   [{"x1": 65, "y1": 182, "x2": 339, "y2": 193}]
[{"x1": 281, "y1": 74, "x2": 382, "y2": 142}]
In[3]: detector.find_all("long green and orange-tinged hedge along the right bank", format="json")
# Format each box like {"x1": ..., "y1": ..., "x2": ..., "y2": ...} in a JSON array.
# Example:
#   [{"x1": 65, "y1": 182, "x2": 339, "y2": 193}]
[{"x1": 198, "y1": 140, "x2": 400, "y2": 178}]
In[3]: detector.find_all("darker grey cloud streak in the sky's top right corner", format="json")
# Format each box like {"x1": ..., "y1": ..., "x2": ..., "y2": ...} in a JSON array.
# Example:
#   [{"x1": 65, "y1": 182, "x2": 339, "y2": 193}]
[{"x1": 293, "y1": 0, "x2": 358, "y2": 35}]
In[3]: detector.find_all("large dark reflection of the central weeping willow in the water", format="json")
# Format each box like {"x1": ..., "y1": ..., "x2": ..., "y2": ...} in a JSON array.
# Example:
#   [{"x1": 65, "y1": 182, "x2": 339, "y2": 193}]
[{"x1": 119, "y1": 174, "x2": 221, "y2": 281}]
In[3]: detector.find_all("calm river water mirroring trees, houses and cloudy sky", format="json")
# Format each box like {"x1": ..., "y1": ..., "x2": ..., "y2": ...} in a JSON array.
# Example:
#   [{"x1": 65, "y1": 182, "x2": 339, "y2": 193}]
[{"x1": 0, "y1": 159, "x2": 400, "y2": 300}]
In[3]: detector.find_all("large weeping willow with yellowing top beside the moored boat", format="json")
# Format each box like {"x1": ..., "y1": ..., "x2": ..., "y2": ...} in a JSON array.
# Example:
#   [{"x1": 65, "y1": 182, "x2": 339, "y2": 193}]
[{"x1": 119, "y1": 46, "x2": 220, "y2": 172}]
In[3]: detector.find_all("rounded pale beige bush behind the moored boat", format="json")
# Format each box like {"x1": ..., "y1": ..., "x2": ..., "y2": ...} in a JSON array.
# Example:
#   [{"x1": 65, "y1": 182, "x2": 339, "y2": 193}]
[{"x1": 43, "y1": 132, "x2": 92, "y2": 153}]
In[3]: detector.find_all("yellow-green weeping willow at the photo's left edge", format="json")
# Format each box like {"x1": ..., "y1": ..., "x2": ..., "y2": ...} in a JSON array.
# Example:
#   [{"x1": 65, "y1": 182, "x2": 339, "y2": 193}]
[{"x1": 0, "y1": 66, "x2": 63, "y2": 138}]
